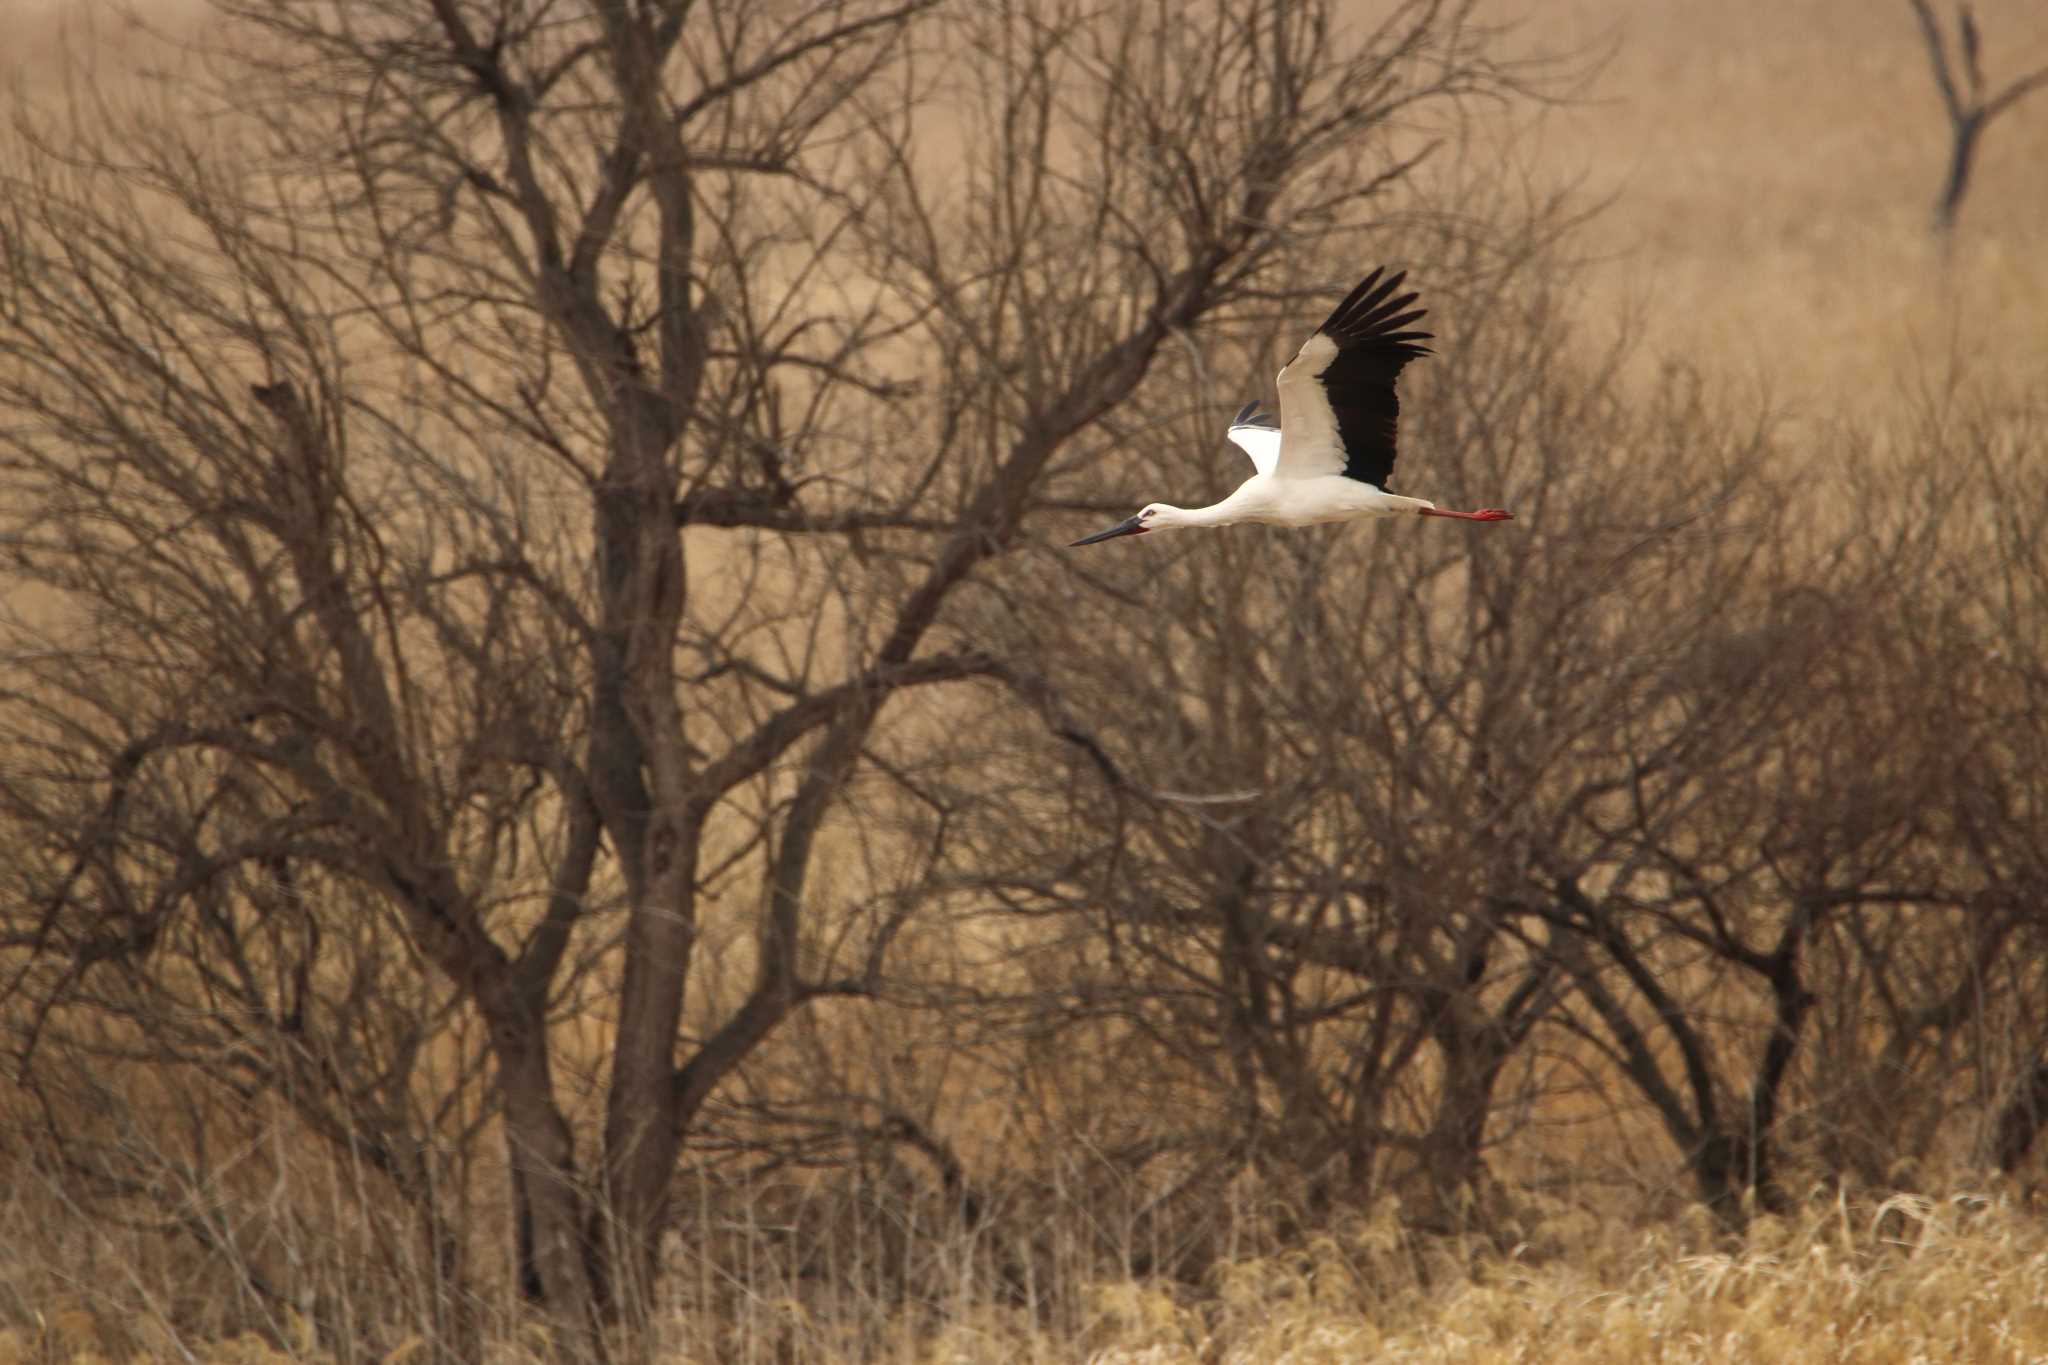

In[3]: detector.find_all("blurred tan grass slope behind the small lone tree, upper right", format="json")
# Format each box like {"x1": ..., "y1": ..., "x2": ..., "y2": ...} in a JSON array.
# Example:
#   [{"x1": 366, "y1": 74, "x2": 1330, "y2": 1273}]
[{"x1": 1513, "y1": 0, "x2": 2048, "y2": 415}]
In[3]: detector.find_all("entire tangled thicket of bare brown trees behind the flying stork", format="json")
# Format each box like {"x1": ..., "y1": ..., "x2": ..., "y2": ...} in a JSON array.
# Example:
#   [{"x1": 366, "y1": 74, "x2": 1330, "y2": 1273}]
[{"x1": 0, "y1": 0, "x2": 2048, "y2": 1359}]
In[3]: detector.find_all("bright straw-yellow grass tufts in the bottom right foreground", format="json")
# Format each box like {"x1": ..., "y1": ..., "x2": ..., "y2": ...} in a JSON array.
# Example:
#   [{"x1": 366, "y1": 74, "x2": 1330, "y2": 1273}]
[{"x1": 1015, "y1": 1195, "x2": 2048, "y2": 1365}]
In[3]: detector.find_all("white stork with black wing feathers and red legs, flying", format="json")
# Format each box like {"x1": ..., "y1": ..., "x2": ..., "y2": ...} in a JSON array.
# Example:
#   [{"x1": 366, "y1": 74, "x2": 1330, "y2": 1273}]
[{"x1": 1073, "y1": 266, "x2": 1513, "y2": 544}]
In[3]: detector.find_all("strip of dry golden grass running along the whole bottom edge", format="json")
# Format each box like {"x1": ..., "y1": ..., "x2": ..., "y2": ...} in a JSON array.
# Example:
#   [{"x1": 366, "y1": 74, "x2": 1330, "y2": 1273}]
[{"x1": 0, "y1": 1193, "x2": 2048, "y2": 1365}]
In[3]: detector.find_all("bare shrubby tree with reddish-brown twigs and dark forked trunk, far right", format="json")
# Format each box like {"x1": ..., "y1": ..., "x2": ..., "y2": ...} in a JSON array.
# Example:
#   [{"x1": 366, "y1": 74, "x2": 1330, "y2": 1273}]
[{"x1": 1523, "y1": 388, "x2": 2023, "y2": 1222}]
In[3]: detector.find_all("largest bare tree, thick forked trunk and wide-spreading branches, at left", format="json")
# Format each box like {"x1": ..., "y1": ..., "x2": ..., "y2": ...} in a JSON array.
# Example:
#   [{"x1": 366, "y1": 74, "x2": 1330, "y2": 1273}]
[{"x1": 0, "y1": 0, "x2": 1540, "y2": 1342}]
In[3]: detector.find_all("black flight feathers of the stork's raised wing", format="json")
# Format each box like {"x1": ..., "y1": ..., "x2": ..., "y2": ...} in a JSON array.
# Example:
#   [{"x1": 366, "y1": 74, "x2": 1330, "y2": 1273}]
[{"x1": 1319, "y1": 266, "x2": 1436, "y2": 489}]
